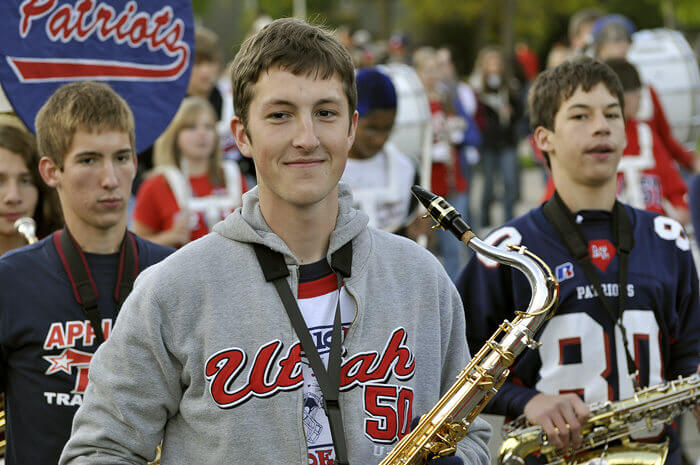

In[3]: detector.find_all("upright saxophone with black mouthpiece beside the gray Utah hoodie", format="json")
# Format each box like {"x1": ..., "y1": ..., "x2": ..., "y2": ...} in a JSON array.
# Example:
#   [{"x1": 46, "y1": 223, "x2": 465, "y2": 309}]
[{"x1": 380, "y1": 186, "x2": 559, "y2": 465}]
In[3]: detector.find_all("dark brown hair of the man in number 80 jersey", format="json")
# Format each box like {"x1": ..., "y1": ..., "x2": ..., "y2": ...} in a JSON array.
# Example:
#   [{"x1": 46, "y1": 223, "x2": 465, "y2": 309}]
[{"x1": 527, "y1": 56, "x2": 625, "y2": 166}]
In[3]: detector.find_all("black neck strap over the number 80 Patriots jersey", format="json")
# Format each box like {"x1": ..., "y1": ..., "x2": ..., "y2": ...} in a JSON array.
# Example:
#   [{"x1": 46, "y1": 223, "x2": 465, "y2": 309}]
[{"x1": 542, "y1": 191, "x2": 639, "y2": 389}]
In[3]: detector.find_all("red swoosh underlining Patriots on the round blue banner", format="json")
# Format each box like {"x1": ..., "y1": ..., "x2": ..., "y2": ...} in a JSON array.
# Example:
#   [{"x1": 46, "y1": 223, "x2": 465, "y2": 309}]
[{"x1": 7, "y1": 51, "x2": 188, "y2": 83}]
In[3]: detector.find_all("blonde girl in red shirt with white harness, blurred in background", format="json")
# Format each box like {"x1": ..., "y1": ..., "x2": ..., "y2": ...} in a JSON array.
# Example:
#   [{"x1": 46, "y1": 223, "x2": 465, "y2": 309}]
[{"x1": 133, "y1": 97, "x2": 246, "y2": 247}]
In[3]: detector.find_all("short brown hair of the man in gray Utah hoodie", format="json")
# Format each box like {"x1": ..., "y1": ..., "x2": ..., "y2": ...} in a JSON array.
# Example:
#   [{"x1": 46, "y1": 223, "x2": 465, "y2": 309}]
[{"x1": 231, "y1": 18, "x2": 357, "y2": 126}]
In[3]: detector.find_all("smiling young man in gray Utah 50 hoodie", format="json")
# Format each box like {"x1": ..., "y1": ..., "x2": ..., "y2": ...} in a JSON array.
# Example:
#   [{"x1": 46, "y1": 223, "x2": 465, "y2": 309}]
[{"x1": 60, "y1": 19, "x2": 489, "y2": 465}]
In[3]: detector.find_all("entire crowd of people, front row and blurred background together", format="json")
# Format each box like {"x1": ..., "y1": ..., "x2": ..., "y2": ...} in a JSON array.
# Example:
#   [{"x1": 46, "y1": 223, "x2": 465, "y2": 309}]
[{"x1": 0, "y1": 10, "x2": 700, "y2": 465}]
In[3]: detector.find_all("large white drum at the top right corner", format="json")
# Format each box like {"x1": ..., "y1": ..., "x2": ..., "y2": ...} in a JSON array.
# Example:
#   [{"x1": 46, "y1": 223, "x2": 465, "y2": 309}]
[{"x1": 627, "y1": 29, "x2": 700, "y2": 148}]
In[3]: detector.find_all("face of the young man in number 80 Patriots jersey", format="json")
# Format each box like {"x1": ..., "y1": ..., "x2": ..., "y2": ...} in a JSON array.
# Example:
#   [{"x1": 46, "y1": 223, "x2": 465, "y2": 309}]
[{"x1": 534, "y1": 83, "x2": 627, "y2": 191}]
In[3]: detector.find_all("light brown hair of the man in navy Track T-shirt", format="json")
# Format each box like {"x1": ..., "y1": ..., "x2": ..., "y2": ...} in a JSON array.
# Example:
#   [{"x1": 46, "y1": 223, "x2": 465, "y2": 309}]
[{"x1": 34, "y1": 81, "x2": 136, "y2": 168}]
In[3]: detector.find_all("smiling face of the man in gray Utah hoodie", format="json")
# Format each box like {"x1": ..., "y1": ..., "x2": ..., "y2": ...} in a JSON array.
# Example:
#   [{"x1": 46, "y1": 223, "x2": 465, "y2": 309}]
[{"x1": 231, "y1": 67, "x2": 357, "y2": 214}]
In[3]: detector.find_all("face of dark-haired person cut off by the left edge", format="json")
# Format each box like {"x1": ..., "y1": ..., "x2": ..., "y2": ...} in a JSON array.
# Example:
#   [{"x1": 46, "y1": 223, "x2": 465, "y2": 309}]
[{"x1": 0, "y1": 147, "x2": 39, "y2": 236}]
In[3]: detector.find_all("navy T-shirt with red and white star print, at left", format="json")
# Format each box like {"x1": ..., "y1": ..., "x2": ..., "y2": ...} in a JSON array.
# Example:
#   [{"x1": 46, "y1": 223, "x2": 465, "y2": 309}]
[{"x1": 0, "y1": 232, "x2": 172, "y2": 465}]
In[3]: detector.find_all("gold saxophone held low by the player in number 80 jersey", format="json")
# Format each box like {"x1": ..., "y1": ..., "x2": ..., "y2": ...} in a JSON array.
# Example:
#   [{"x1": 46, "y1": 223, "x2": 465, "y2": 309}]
[{"x1": 498, "y1": 374, "x2": 700, "y2": 465}]
